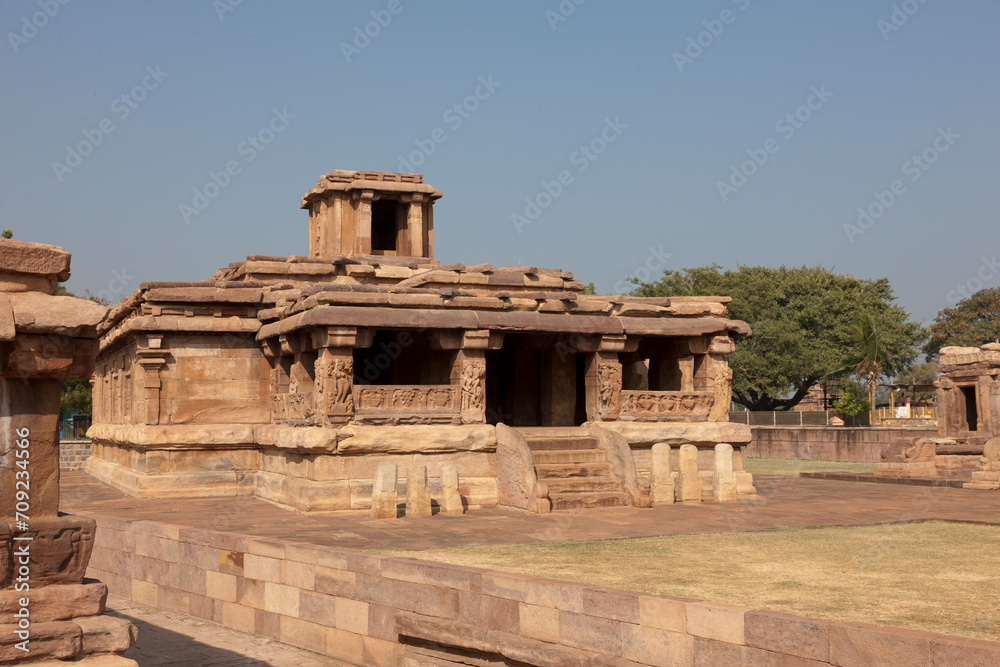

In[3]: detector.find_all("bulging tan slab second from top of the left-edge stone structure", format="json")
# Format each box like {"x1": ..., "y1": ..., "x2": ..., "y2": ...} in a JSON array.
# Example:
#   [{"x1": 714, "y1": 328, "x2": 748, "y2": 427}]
[{"x1": 7, "y1": 292, "x2": 108, "y2": 338}]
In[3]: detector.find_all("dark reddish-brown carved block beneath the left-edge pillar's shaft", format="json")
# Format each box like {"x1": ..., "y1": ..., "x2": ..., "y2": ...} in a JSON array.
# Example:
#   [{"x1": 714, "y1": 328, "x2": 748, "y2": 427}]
[{"x1": 8, "y1": 516, "x2": 97, "y2": 589}]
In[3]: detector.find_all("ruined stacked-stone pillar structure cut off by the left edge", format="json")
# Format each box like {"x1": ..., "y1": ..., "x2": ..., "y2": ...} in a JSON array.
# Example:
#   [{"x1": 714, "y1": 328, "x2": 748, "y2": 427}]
[{"x1": 0, "y1": 239, "x2": 136, "y2": 667}]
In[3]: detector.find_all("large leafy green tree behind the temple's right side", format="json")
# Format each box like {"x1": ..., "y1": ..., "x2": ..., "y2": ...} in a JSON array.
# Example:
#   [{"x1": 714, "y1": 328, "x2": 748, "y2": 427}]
[{"x1": 632, "y1": 265, "x2": 925, "y2": 410}]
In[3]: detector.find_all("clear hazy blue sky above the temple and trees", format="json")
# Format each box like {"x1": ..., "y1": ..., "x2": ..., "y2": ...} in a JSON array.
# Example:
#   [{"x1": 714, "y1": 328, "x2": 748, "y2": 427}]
[{"x1": 0, "y1": 0, "x2": 1000, "y2": 319}]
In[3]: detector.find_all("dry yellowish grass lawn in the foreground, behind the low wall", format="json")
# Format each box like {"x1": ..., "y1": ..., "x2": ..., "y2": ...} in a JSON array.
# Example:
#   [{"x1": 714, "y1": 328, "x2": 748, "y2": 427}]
[{"x1": 382, "y1": 522, "x2": 1000, "y2": 641}]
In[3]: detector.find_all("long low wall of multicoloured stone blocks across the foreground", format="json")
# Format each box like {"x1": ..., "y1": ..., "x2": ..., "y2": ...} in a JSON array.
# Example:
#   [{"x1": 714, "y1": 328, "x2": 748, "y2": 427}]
[{"x1": 80, "y1": 517, "x2": 1000, "y2": 667}]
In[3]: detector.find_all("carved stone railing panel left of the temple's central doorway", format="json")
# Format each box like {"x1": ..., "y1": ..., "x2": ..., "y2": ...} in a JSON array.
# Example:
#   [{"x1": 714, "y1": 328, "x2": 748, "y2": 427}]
[{"x1": 354, "y1": 384, "x2": 462, "y2": 424}]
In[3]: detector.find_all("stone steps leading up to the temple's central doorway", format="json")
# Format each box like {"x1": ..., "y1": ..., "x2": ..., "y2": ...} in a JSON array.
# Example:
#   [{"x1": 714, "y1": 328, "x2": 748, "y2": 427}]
[{"x1": 518, "y1": 427, "x2": 630, "y2": 510}]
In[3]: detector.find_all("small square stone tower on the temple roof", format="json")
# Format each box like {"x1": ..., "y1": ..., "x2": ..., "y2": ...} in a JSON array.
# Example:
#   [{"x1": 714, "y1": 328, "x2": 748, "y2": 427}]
[{"x1": 302, "y1": 169, "x2": 441, "y2": 259}]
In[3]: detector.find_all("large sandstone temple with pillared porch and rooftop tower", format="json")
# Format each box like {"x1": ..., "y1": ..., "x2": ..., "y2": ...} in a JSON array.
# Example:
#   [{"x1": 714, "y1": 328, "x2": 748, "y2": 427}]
[{"x1": 87, "y1": 171, "x2": 755, "y2": 512}]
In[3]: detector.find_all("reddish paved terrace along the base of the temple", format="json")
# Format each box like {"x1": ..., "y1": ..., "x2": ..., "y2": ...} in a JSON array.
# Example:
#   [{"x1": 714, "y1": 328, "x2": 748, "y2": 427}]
[{"x1": 60, "y1": 472, "x2": 1000, "y2": 550}]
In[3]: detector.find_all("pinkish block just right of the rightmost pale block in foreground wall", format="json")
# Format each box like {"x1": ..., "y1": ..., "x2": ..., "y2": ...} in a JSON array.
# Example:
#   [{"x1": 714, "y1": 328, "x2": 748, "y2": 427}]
[{"x1": 744, "y1": 610, "x2": 831, "y2": 662}]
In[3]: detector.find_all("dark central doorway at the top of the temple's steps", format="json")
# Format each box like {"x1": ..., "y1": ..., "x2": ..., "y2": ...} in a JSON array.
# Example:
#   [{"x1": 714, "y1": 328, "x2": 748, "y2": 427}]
[{"x1": 486, "y1": 334, "x2": 587, "y2": 426}]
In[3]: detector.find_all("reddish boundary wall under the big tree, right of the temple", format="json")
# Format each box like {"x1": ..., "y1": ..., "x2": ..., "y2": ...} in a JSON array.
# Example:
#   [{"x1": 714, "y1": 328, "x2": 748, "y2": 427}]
[{"x1": 744, "y1": 426, "x2": 937, "y2": 463}]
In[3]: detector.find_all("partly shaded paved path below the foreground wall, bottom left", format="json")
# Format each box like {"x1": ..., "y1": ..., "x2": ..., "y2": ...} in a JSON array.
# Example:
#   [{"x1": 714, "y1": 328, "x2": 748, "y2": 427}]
[{"x1": 108, "y1": 596, "x2": 350, "y2": 667}]
